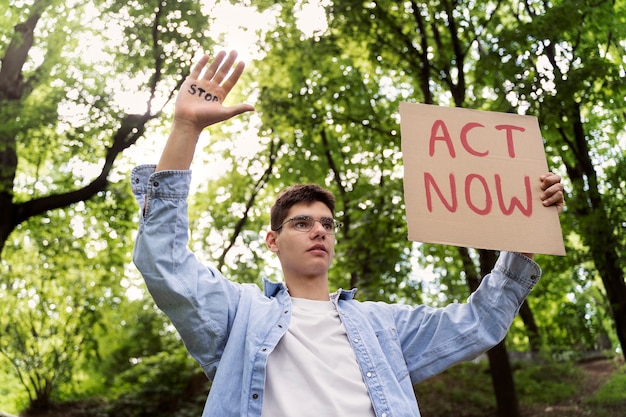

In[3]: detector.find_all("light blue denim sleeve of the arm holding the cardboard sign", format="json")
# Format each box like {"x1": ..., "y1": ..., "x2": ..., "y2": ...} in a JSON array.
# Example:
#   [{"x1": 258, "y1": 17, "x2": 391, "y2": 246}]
[{"x1": 394, "y1": 252, "x2": 541, "y2": 383}]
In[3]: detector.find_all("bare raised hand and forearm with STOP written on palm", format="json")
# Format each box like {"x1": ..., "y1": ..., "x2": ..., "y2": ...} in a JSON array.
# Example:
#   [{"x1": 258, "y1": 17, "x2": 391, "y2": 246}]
[{"x1": 156, "y1": 51, "x2": 254, "y2": 171}]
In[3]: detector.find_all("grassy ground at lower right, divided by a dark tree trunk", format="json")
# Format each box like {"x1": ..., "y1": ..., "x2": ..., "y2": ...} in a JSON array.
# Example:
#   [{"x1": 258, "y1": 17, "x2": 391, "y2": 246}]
[{"x1": 415, "y1": 359, "x2": 626, "y2": 417}]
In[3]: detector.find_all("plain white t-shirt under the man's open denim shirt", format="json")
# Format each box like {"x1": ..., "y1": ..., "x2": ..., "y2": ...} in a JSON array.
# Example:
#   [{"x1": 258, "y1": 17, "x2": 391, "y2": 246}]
[{"x1": 262, "y1": 298, "x2": 375, "y2": 417}]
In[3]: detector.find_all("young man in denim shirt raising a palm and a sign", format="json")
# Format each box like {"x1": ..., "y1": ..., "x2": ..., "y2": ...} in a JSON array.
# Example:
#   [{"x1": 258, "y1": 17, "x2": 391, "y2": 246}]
[{"x1": 132, "y1": 52, "x2": 563, "y2": 417}]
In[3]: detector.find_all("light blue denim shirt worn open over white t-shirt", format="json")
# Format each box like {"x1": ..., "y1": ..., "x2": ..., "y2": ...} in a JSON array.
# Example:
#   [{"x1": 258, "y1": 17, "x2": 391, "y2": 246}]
[{"x1": 131, "y1": 165, "x2": 541, "y2": 417}]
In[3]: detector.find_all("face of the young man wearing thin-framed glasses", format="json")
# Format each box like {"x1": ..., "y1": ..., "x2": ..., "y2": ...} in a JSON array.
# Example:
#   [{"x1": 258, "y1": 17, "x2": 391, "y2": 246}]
[{"x1": 266, "y1": 201, "x2": 335, "y2": 280}]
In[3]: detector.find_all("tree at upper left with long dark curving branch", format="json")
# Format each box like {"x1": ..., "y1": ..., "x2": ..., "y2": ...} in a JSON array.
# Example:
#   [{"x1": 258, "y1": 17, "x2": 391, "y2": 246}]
[{"x1": 0, "y1": 0, "x2": 214, "y2": 253}]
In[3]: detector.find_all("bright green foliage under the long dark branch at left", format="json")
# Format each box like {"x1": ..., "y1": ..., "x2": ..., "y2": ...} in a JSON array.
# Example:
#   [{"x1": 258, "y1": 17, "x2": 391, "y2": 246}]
[{"x1": 0, "y1": 180, "x2": 132, "y2": 408}]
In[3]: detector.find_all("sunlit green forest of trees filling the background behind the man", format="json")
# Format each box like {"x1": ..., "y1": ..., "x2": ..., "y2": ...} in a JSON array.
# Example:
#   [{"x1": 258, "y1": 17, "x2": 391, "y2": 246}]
[{"x1": 0, "y1": 0, "x2": 626, "y2": 417}]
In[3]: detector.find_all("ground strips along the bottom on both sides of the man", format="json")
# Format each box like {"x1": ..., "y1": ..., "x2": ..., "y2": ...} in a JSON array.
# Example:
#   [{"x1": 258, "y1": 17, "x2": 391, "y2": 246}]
[{"x1": 6, "y1": 359, "x2": 626, "y2": 417}]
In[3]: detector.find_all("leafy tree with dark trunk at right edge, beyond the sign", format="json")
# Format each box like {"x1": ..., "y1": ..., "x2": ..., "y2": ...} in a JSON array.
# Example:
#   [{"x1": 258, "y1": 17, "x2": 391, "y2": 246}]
[{"x1": 478, "y1": 1, "x2": 626, "y2": 355}]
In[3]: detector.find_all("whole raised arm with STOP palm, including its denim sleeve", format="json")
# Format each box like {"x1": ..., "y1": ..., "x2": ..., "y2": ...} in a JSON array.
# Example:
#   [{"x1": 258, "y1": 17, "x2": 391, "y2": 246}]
[{"x1": 131, "y1": 52, "x2": 254, "y2": 376}]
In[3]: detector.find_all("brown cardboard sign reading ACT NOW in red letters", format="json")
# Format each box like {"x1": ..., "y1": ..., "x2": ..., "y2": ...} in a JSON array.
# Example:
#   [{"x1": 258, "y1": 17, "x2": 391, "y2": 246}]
[{"x1": 400, "y1": 103, "x2": 565, "y2": 255}]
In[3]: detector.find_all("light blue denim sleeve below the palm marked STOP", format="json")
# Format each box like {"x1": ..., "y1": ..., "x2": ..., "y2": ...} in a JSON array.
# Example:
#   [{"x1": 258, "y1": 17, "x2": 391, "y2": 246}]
[{"x1": 131, "y1": 165, "x2": 240, "y2": 369}]
